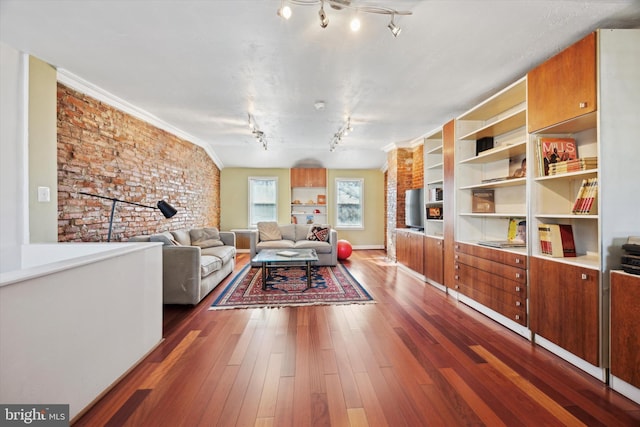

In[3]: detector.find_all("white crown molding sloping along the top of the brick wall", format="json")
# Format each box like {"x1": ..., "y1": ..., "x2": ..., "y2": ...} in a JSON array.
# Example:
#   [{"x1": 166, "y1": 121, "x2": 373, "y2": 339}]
[{"x1": 57, "y1": 68, "x2": 224, "y2": 170}]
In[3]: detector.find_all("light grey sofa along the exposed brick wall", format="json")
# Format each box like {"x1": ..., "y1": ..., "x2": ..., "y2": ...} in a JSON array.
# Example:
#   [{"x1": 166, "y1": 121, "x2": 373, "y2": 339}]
[{"x1": 129, "y1": 227, "x2": 236, "y2": 305}]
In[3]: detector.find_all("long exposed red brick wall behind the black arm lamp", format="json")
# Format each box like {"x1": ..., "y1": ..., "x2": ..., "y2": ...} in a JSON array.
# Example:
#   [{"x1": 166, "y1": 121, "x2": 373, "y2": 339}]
[{"x1": 58, "y1": 83, "x2": 220, "y2": 242}]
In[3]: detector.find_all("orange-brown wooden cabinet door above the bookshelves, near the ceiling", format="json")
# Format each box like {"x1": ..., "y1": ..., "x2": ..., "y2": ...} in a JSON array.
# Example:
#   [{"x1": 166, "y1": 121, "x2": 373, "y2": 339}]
[{"x1": 527, "y1": 33, "x2": 597, "y2": 132}]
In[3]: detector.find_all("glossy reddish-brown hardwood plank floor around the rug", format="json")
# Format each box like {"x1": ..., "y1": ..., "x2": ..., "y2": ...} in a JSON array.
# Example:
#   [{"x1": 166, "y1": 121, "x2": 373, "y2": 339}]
[{"x1": 75, "y1": 251, "x2": 640, "y2": 427}]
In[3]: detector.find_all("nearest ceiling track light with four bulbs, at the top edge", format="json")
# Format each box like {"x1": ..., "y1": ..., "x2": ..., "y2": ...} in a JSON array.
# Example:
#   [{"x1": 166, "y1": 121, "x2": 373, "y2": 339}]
[{"x1": 278, "y1": 0, "x2": 413, "y2": 37}]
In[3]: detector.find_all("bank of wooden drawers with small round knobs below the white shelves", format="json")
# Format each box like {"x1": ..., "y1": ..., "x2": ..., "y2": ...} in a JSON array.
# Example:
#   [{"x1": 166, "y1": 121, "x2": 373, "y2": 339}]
[{"x1": 454, "y1": 242, "x2": 527, "y2": 326}]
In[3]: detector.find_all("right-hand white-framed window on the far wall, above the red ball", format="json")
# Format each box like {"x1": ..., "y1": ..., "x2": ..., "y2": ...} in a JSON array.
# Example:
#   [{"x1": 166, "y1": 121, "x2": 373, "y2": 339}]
[{"x1": 336, "y1": 178, "x2": 364, "y2": 228}]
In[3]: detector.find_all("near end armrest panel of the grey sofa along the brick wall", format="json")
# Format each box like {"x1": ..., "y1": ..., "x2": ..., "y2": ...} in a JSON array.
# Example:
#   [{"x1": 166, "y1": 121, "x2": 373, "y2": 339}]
[{"x1": 162, "y1": 246, "x2": 200, "y2": 304}]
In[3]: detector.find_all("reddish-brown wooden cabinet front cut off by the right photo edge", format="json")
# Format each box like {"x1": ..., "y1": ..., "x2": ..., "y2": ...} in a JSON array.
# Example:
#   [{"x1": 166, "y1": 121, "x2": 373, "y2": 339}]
[{"x1": 610, "y1": 271, "x2": 640, "y2": 387}]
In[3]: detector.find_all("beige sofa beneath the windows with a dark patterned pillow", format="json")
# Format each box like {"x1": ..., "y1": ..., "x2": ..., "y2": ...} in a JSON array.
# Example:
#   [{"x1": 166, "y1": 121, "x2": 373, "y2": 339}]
[{"x1": 249, "y1": 222, "x2": 338, "y2": 267}]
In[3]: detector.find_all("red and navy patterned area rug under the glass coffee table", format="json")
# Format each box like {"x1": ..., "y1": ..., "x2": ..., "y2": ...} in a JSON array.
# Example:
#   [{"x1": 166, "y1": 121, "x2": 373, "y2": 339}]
[{"x1": 210, "y1": 264, "x2": 375, "y2": 310}]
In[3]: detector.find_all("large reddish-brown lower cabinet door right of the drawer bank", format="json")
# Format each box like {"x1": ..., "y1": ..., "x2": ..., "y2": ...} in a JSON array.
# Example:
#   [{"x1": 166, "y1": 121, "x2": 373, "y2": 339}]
[{"x1": 529, "y1": 257, "x2": 601, "y2": 366}]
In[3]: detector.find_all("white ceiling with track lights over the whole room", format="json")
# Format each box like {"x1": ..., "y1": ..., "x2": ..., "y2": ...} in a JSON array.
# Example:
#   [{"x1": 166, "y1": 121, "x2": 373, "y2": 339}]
[{"x1": 0, "y1": 0, "x2": 640, "y2": 169}]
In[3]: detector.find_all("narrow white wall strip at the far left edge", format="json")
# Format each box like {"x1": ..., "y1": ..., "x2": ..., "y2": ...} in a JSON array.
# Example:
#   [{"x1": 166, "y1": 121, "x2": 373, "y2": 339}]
[{"x1": 0, "y1": 43, "x2": 28, "y2": 272}]
